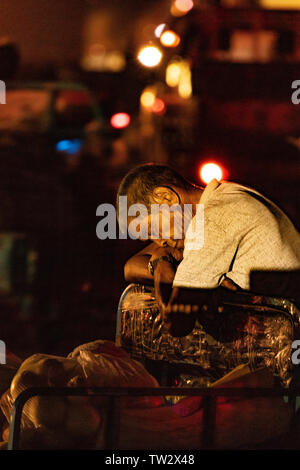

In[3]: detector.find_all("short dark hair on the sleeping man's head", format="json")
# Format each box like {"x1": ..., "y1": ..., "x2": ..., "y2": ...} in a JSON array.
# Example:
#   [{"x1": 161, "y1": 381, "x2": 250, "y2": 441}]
[{"x1": 117, "y1": 163, "x2": 194, "y2": 209}]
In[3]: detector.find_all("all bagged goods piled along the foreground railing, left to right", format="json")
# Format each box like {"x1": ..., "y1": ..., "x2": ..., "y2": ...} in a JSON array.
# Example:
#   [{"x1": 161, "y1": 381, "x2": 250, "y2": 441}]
[{"x1": 0, "y1": 341, "x2": 292, "y2": 450}]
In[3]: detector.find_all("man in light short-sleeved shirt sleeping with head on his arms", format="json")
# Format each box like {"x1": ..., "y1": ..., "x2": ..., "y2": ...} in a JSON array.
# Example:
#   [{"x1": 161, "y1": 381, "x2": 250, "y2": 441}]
[{"x1": 117, "y1": 164, "x2": 300, "y2": 332}]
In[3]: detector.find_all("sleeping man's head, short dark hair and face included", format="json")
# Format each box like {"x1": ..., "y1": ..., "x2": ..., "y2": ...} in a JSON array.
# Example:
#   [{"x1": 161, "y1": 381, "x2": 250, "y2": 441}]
[{"x1": 117, "y1": 164, "x2": 201, "y2": 247}]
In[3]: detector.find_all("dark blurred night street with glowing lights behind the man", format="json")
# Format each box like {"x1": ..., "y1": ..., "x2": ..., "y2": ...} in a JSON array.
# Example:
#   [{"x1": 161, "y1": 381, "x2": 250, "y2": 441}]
[{"x1": 0, "y1": 0, "x2": 300, "y2": 357}]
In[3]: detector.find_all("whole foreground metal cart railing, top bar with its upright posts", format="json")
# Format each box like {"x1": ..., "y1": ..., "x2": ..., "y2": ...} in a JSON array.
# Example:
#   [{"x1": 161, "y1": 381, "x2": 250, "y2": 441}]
[{"x1": 8, "y1": 387, "x2": 300, "y2": 450}]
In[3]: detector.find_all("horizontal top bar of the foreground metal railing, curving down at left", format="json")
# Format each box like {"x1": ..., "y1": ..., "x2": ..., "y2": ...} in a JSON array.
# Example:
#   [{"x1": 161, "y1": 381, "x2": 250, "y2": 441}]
[{"x1": 8, "y1": 387, "x2": 300, "y2": 450}]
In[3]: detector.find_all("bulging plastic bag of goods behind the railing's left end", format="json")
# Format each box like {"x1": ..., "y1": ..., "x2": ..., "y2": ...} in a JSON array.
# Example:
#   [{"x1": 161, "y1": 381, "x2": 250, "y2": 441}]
[{"x1": 1, "y1": 340, "x2": 162, "y2": 449}]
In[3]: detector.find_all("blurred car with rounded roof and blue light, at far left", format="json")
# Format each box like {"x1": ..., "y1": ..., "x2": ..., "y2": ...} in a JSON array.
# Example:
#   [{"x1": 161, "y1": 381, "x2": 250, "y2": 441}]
[{"x1": 0, "y1": 82, "x2": 104, "y2": 159}]
